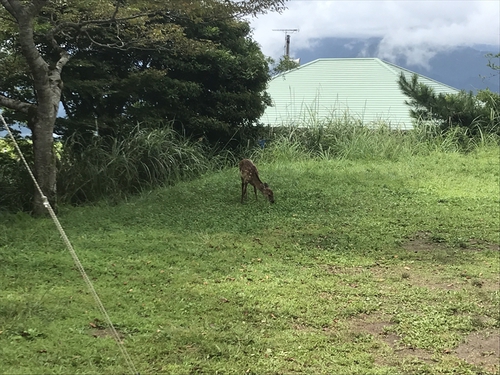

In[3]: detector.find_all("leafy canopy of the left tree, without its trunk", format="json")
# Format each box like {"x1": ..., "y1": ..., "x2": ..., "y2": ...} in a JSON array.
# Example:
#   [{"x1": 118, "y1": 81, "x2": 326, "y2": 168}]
[{"x1": 0, "y1": 0, "x2": 285, "y2": 123}]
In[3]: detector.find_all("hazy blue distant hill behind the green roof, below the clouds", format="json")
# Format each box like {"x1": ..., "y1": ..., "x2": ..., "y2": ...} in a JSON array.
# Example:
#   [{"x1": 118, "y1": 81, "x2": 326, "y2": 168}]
[{"x1": 292, "y1": 38, "x2": 500, "y2": 92}]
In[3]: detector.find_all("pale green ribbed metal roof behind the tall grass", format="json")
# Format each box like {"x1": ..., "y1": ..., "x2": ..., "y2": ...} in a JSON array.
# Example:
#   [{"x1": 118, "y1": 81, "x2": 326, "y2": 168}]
[{"x1": 261, "y1": 58, "x2": 459, "y2": 129}]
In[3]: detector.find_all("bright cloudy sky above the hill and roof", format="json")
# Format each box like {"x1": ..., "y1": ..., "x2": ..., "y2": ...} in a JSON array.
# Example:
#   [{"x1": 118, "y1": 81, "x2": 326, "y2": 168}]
[{"x1": 251, "y1": 0, "x2": 500, "y2": 65}]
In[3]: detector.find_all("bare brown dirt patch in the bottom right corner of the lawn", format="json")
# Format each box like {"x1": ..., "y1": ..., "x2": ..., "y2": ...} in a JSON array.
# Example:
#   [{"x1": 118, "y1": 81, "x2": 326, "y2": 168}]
[{"x1": 453, "y1": 330, "x2": 500, "y2": 373}]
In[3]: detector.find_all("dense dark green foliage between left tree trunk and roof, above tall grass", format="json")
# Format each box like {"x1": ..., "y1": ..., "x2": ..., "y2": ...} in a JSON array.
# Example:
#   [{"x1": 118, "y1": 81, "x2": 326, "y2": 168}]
[{"x1": 57, "y1": 19, "x2": 269, "y2": 144}]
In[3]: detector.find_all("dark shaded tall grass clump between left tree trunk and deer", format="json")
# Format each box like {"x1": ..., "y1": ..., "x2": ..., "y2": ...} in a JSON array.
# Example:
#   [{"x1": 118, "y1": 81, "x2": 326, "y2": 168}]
[{"x1": 58, "y1": 127, "x2": 234, "y2": 204}]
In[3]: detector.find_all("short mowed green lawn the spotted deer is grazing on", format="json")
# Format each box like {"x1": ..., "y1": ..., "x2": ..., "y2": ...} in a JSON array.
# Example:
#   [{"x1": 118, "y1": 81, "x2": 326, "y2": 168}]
[{"x1": 0, "y1": 148, "x2": 500, "y2": 374}]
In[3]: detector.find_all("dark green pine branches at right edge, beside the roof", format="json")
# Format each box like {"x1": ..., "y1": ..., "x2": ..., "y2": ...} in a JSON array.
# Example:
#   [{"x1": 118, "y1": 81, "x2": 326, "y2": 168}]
[{"x1": 399, "y1": 74, "x2": 500, "y2": 137}]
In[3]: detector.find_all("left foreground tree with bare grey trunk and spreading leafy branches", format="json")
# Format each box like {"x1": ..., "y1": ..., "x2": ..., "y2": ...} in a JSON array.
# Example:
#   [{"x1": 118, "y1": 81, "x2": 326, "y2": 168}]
[{"x1": 0, "y1": 0, "x2": 285, "y2": 215}]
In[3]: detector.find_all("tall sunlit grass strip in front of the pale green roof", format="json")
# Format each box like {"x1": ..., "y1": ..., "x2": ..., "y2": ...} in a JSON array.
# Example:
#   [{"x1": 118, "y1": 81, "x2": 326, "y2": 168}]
[{"x1": 256, "y1": 111, "x2": 499, "y2": 164}]
